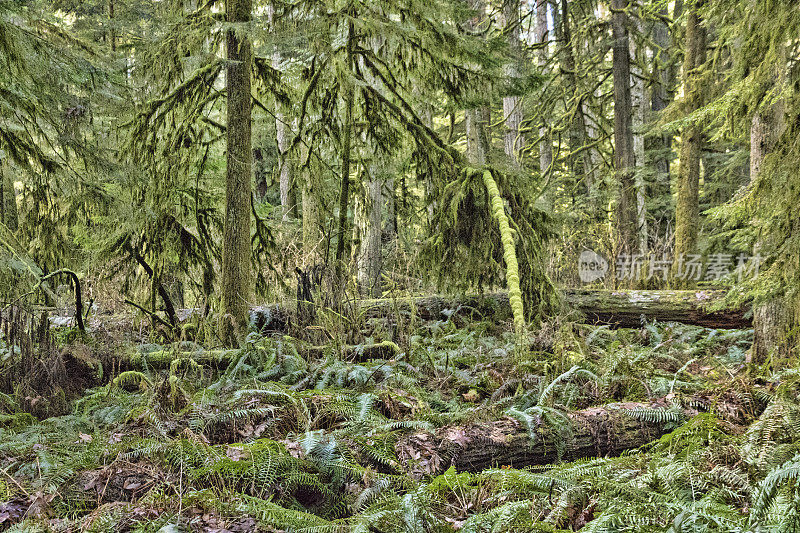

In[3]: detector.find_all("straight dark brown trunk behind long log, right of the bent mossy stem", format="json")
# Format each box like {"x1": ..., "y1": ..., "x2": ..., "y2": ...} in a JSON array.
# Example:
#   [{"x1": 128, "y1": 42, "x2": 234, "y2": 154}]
[{"x1": 611, "y1": 0, "x2": 636, "y2": 268}]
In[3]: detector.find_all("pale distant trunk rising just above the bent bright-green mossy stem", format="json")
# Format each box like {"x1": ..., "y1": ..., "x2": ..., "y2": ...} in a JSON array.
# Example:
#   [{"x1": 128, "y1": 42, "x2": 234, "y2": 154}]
[{"x1": 503, "y1": 0, "x2": 525, "y2": 168}]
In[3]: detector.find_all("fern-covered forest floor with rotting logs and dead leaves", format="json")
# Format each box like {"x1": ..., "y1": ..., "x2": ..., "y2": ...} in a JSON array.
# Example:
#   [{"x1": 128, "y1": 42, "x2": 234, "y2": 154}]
[{"x1": 0, "y1": 310, "x2": 800, "y2": 532}]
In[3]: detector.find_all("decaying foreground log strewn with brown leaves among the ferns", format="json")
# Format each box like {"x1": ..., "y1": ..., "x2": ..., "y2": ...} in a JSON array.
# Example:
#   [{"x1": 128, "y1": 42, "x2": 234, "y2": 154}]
[{"x1": 396, "y1": 402, "x2": 680, "y2": 478}]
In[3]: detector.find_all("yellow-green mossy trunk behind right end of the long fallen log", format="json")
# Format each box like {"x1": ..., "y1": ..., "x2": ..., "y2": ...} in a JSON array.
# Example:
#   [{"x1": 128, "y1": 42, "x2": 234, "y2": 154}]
[{"x1": 675, "y1": 6, "x2": 706, "y2": 266}]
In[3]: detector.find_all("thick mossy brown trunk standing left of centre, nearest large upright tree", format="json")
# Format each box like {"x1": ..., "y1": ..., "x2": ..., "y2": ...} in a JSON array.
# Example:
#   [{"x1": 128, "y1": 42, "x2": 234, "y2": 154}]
[{"x1": 220, "y1": 0, "x2": 253, "y2": 345}]
